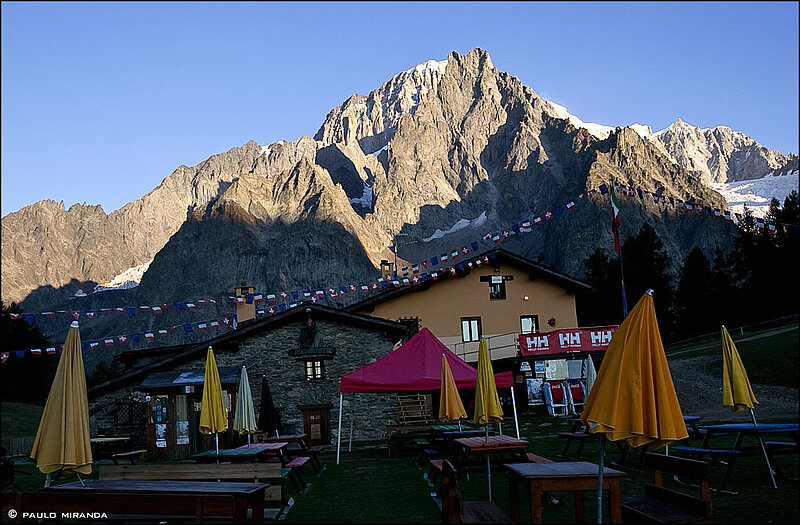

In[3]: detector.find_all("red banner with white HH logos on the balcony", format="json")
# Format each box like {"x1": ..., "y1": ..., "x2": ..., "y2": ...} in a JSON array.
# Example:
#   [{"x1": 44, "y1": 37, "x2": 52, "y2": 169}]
[{"x1": 519, "y1": 326, "x2": 618, "y2": 355}]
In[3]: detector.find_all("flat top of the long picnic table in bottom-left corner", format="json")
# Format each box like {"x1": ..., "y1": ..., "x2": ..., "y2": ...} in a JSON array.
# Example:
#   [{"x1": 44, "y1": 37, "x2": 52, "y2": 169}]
[{"x1": 42, "y1": 479, "x2": 269, "y2": 495}]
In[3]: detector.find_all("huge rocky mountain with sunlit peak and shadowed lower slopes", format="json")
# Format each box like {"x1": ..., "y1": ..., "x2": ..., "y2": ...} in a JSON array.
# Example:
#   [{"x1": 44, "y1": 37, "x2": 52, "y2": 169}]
[{"x1": 2, "y1": 48, "x2": 776, "y2": 316}]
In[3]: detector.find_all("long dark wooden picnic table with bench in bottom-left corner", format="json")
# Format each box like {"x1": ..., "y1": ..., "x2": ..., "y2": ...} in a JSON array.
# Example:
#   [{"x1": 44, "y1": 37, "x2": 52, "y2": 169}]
[{"x1": 3, "y1": 479, "x2": 269, "y2": 523}]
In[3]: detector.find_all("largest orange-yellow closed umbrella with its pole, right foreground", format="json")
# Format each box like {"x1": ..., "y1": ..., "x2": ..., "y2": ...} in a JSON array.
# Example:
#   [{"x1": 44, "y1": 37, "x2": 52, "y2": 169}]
[{"x1": 581, "y1": 290, "x2": 689, "y2": 523}]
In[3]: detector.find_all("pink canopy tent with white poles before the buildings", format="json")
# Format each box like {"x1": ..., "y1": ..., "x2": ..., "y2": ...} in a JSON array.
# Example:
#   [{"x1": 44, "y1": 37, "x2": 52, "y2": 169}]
[{"x1": 336, "y1": 328, "x2": 519, "y2": 464}]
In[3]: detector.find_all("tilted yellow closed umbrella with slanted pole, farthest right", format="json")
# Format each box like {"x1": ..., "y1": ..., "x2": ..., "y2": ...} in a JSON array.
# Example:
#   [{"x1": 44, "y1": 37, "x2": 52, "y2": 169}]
[{"x1": 721, "y1": 325, "x2": 778, "y2": 488}]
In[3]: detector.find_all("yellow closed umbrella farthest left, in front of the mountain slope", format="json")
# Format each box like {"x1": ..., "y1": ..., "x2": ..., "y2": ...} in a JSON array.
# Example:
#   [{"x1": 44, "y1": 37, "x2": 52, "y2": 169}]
[{"x1": 31, "y1": 321, "x2": 92, "y2": 486}]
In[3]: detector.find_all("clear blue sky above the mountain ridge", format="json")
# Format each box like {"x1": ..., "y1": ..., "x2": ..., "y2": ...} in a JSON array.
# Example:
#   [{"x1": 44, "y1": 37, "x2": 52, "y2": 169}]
[{"x1": 1, "y1": 2, "x2": 798, "y2": 216}]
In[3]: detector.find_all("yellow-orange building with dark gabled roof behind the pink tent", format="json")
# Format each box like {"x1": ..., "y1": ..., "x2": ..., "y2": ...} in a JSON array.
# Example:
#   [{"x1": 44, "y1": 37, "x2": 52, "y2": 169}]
[{"x1": 347, "y1": 248, "x2": 590, "y2": 362}]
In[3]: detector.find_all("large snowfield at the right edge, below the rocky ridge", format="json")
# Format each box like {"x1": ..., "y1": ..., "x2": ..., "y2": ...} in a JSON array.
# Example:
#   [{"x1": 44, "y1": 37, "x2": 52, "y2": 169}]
[{"x1": 711, "y1": 170, "x2": 798, "y2": 217}]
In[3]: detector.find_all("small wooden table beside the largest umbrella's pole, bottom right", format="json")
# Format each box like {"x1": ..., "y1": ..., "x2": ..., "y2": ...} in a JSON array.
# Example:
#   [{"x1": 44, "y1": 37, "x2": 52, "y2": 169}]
[{"x1": 503, "y1": 461, "x2": 625, "y2": 523}]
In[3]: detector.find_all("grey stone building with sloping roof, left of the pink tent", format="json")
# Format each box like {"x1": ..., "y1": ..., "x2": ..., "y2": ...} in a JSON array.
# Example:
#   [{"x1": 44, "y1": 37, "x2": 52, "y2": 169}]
[{"x1": 89, "y1": 303, "x2": 409, "y2": 459}]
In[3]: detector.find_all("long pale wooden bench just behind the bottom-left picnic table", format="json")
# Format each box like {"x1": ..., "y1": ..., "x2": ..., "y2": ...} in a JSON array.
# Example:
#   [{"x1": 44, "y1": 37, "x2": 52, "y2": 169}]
[{"x1": 98, "y1": 463, "x2": 292, "y2": 506}]
